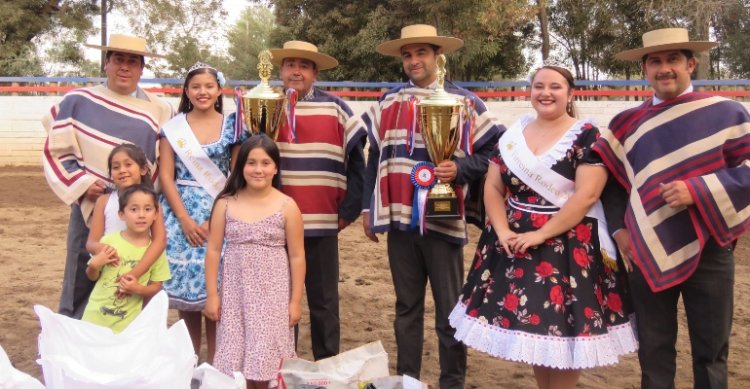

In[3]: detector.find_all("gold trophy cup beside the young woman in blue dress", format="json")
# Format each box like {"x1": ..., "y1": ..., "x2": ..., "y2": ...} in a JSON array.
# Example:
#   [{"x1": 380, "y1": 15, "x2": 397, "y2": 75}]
[{"x1": 242, "y1": 50, "x2": 284, "y2": 141}]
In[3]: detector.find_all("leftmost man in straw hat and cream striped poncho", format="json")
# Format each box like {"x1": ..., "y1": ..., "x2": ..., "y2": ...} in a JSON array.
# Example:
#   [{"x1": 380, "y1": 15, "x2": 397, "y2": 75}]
[{"x1": 42, "y1": 34, "x2": 172, "y2": 318}]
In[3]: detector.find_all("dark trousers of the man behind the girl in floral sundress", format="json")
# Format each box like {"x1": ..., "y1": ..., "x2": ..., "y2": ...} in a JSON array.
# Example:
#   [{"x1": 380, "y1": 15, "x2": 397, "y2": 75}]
[{"x1": 305, "y1": 236, "x2": 341, "y2": 360}]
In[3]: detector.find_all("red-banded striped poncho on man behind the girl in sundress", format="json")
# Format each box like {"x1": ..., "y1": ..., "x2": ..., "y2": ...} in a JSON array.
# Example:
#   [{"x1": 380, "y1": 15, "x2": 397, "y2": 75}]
[{"x1": 276, "y1": 88, "x2": 367, "y2": 237}]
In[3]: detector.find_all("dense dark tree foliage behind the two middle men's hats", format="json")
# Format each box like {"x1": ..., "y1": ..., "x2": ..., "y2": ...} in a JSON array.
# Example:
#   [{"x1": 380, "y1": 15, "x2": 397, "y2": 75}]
[{"x1": 256, "y1": 0, "x2": 535, "y2": 81}]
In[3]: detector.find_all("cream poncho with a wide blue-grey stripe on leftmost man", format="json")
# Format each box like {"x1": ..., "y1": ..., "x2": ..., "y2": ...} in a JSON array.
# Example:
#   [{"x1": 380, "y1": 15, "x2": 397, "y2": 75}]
[{"x1": 42, "y1": 85, "x2": 172, "y2": 220}]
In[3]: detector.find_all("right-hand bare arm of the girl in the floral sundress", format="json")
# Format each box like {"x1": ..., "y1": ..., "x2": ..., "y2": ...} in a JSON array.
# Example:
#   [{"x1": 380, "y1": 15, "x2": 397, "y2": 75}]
[{"x1": 284, "y1": 196, "x2": 305, "y2": 326}]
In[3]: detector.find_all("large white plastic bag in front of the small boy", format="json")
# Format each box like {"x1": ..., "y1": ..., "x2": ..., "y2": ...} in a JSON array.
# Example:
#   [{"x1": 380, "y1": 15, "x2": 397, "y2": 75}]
[{"x1": 34, "y1": 291, "x2": 196, "y2": 389}]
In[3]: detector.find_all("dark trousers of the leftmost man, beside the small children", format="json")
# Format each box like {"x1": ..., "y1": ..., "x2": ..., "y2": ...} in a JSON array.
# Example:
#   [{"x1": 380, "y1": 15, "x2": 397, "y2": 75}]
[{"x1": 58, "y1": 204, "x2": 94, "y2": 319}]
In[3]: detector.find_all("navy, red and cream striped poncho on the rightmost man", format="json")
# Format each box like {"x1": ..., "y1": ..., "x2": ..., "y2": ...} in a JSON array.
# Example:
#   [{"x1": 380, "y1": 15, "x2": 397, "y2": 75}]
[{"x1": 593, "y1": 92, "x2": 750, "y2": 292}]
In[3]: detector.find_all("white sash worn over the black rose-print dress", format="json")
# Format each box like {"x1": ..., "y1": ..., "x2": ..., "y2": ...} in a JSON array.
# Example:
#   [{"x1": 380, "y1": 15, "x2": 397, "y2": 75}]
[{"x1": 499, "y1": 115, "x2": 617, "y2": 260}]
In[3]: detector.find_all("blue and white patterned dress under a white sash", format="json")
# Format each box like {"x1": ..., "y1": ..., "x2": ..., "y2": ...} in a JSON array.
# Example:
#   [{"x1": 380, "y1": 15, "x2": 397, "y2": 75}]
[{"x1": 160, "y1": 113, "x2": 247, "y2": 311}]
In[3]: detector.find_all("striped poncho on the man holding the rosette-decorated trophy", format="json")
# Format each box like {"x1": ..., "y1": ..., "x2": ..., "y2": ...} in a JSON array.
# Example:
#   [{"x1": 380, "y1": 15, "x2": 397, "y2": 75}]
[{"x1": 363, "y1": 84, "x2": 505, "y2": 244}]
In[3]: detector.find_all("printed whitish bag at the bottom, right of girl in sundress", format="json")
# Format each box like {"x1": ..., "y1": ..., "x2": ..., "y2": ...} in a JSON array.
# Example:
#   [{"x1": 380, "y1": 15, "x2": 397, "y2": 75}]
[{"x1": 279, "y1": 341, "x2": 389, "y2": 389}]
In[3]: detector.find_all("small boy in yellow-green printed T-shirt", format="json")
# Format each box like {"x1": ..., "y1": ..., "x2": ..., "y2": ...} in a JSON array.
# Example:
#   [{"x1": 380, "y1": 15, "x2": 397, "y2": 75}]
[{"x1": 81, "y1": 184, "x2": 171, "y2": 333}]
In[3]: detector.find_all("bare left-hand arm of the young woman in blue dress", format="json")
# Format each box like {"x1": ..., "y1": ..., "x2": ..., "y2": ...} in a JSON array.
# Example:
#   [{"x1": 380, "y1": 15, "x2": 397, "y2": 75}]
[{"x1": 159, "y1": 140, "x2": 208, "y2": 246}]
